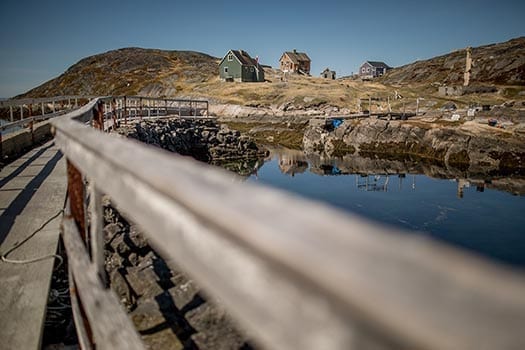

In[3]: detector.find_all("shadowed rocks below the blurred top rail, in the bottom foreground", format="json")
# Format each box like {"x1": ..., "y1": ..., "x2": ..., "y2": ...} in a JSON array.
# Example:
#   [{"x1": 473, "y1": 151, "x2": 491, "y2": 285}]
[{"x1": 104, "y1": 200, "x2": 250, "y2": 350}]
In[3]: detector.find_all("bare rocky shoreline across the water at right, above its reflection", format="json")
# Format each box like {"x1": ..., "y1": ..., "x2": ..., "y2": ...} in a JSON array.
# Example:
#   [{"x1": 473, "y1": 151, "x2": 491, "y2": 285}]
[{"x1": 303, "y1": 118, "x2": 525, "y2": 173}]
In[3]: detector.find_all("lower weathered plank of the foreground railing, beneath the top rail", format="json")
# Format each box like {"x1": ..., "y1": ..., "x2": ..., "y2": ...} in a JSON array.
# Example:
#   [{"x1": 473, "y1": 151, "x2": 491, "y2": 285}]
[{"x1": 62, "y1": 217, "x2": 144, "y2": 349}]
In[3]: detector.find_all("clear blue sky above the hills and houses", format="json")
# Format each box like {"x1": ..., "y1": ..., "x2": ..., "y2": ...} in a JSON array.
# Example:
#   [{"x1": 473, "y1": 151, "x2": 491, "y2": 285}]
[{"x1": 0, "y1": 0, "x2": 525, "y2": 97}]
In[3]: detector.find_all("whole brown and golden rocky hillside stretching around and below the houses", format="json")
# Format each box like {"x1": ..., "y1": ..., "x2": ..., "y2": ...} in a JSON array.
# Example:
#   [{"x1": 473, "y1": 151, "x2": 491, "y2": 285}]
[{"x1": 18, "y1": 37, "x2": 525, "y2": 117}]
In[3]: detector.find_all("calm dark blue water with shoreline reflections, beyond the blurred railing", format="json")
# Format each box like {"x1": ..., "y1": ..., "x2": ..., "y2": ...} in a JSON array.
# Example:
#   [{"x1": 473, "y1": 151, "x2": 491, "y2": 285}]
[{"x1": 248, "y1": 150, "x2": 525, "y2": 269}]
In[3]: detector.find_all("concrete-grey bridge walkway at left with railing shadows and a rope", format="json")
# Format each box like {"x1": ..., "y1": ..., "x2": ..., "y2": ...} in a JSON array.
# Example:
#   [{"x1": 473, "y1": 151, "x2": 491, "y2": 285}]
[{"x1": 0, "y1": 141, "x2": 67, "y2": 349}]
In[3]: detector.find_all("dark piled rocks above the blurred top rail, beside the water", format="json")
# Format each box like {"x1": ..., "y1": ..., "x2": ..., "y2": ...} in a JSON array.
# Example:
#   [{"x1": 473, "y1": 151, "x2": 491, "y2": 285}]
[{"x1": 123, "y1": 118, "x2": 267, "y2": 162}]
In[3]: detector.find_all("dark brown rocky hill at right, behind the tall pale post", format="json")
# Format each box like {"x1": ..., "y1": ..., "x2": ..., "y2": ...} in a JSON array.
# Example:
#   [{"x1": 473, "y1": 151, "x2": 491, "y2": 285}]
[{"x1": 379, "y1": 37, "x2": 525, "y2": 85}]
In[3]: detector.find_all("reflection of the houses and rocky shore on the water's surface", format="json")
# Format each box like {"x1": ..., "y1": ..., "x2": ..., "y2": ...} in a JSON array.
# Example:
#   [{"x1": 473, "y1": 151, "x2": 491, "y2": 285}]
[{"x1": 264, "y1": 148, "x2": 525, "y2": 198}]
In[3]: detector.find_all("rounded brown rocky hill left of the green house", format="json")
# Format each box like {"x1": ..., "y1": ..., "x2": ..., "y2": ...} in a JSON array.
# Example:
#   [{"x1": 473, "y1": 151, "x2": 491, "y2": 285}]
[{"x1": 23, "y1": 48, "x2": 218, "y2": 97}]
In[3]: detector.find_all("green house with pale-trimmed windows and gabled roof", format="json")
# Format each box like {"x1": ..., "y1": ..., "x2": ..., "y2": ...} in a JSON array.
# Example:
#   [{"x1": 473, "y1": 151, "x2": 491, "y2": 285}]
[{"x1": 219, "y1": 50, "x2": 264, "y2": 82}]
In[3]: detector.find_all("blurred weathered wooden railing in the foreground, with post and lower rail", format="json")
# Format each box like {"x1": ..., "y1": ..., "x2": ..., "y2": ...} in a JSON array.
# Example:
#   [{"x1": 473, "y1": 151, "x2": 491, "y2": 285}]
[{"x1": 53, "y1": 99, "x2": 525, "y2": 350}]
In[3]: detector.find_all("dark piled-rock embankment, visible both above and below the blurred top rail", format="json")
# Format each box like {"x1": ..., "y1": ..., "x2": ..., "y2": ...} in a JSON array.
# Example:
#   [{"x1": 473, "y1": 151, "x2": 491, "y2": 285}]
[{"x1": 104, "y1": 118, "x2": 267, "y2": 349}]
